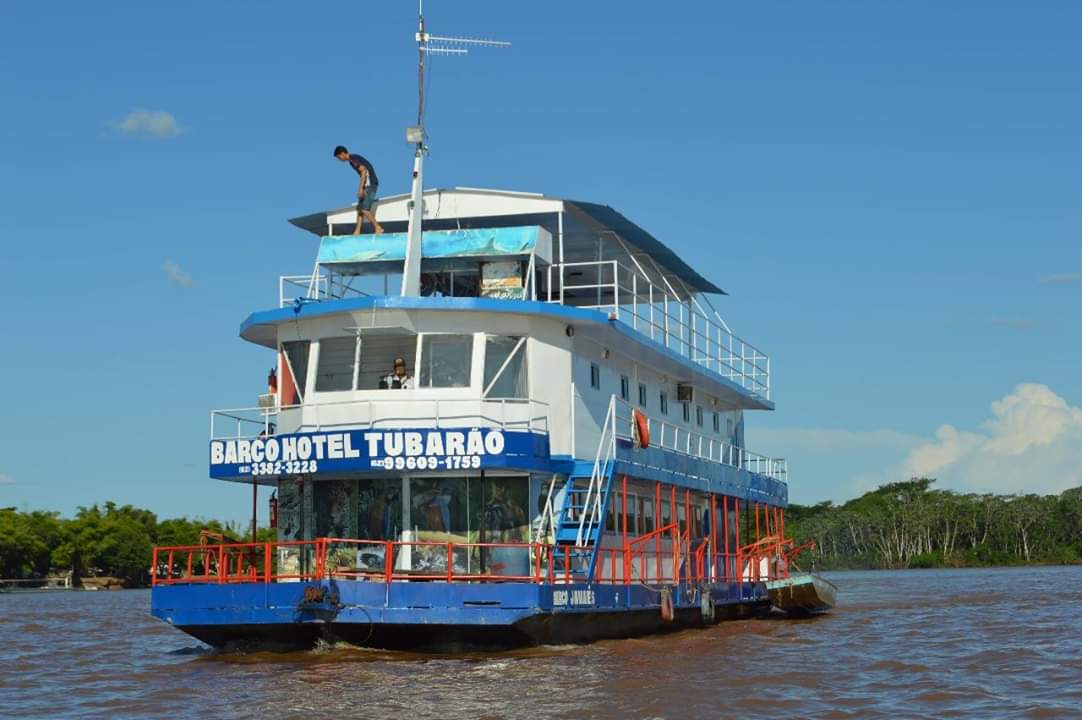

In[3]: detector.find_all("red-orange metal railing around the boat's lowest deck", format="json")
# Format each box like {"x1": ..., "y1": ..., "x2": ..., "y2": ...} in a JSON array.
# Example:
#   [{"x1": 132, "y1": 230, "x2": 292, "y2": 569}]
[{"x1": 151, "y1": 532, "x2": 808, "y2": 586}]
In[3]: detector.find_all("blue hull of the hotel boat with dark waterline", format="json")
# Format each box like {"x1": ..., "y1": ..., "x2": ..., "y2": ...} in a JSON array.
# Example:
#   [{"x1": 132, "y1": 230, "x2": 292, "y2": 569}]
[{"x1": 151, "y1": 580, "x2": 769, "y2": 651}]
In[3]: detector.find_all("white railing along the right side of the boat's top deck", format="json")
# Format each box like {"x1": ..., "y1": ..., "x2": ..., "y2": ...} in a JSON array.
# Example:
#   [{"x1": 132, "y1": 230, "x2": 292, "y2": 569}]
[{"x1": 545, "y1": 260, "x2": 770, "y2": 400}]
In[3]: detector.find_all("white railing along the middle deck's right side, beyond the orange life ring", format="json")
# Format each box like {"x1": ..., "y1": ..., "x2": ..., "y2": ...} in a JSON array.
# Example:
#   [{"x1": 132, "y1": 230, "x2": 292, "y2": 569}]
[{"x1": 612, "y1": 395, "x2": 789, "y2": 483}]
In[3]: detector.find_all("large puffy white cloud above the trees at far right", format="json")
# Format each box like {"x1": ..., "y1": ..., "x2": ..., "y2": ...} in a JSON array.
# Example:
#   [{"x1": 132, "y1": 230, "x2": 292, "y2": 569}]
[{"x1": 897, "y1": 383, "x2": 1082, "y2": 493}]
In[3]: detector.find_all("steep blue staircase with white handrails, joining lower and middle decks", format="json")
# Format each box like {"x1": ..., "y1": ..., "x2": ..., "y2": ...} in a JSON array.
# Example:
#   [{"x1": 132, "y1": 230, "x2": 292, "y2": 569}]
[{"x1": 553, "y1": 395, "x2": 617, "y2": 582}]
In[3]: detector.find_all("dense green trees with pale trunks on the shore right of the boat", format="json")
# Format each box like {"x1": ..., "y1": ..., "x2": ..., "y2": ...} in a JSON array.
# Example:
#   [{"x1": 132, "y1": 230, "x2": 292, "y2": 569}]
[{"x1": 786, "y1": 477, "x2": 1082, "y2": 568}]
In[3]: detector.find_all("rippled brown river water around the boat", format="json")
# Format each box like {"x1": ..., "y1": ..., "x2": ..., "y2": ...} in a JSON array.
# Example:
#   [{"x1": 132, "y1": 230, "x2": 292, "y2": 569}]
[{"x1": 0, "y1": 567, "x2": 1082, "y2": 720}]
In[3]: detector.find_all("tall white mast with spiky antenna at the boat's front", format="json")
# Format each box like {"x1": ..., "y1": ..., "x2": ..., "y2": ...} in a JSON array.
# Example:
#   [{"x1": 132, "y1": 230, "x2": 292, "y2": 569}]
[{"x1": 401, "y1": 0, "x2": 511, "y2": 297}]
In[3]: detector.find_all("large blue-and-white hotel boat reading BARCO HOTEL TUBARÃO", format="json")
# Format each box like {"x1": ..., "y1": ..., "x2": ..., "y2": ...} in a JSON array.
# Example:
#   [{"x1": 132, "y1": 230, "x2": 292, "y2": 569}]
[{"x1": 150, "y1": 4, "x2": 813, "y2": 650}]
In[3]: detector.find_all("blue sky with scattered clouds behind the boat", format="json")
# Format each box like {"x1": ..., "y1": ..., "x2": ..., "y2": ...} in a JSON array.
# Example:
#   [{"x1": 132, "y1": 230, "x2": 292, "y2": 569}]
[{"x1": 0, "y1": 0, "x2": 1082, "y2": 519}]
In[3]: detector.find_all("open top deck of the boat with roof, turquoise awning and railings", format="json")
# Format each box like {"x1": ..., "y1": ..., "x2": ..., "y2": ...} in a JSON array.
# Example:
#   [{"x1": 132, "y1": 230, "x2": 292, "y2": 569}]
[{"x1": 278, "y1": 188, "x2": 773, "y2": 400}]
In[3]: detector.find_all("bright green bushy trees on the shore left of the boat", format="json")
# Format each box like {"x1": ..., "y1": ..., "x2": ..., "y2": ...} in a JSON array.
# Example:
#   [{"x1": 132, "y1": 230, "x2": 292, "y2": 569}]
[{"x1": 0, "y1": 502, "x2": 273, "y2": 587}]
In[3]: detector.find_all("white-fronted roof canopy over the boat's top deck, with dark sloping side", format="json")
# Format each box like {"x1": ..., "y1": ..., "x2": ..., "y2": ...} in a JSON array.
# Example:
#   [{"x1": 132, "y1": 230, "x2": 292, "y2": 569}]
[{"x1": 289, "y1": 187, "x2": 728, "y2": 294}]
